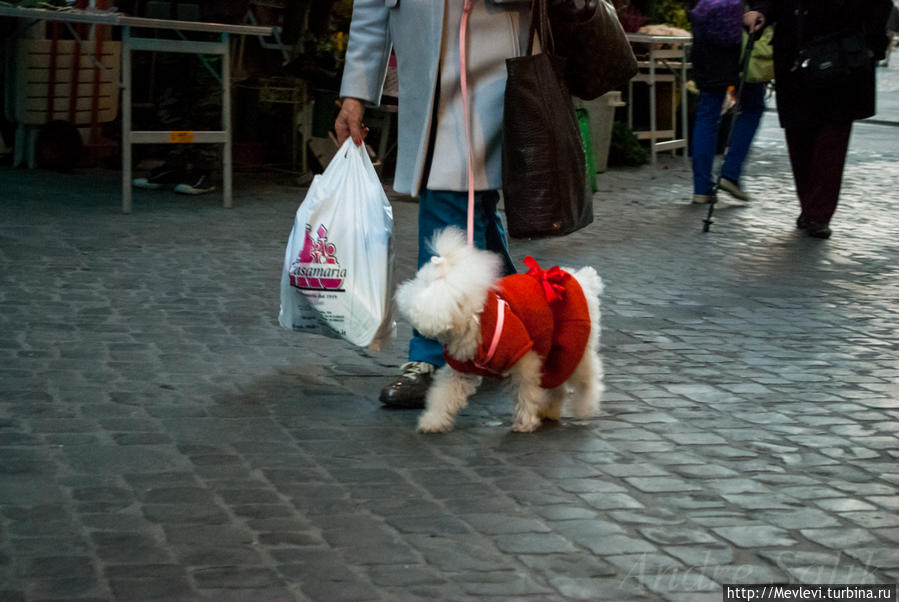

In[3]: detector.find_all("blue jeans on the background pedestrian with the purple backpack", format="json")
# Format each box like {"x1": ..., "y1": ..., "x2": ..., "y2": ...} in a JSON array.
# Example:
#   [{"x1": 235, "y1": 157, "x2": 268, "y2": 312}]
[{"x1": 692, "y1": 83, "x2": 765, "y2": 194}]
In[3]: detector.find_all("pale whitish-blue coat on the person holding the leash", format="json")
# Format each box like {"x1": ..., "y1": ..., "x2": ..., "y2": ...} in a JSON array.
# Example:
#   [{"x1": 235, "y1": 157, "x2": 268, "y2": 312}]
[{"x1": 340, "y1": 0, "x2": 530, "y2": 194}]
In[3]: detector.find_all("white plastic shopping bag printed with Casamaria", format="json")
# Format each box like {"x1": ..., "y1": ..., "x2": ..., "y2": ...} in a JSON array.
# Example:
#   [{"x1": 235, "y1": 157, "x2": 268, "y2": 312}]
[{"x1": 278, "y1": 138, "x2": 395, "y2": 349}]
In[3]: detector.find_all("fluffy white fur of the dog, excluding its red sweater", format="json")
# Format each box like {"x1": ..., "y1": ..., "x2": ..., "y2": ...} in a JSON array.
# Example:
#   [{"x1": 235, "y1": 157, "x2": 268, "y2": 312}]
[{"x1": 396, "y1": 227, "x2": 603, "y2": 433}]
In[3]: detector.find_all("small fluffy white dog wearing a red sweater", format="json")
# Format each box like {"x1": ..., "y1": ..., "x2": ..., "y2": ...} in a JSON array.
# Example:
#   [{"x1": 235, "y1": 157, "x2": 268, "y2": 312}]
[{"x1": 396, "y1": 227, "x2": 603, "y2": 433}]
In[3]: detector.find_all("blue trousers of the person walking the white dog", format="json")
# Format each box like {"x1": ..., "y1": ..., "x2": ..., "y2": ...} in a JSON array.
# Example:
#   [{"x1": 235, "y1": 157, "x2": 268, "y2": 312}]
[{"x1": 409, "y1": 189, "x2": 515, "y2": 366}]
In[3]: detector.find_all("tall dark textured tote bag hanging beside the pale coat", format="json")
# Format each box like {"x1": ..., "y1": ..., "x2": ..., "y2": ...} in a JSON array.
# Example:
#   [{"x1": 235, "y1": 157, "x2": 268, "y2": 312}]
[{"x1": 503, "y1": 0, "x2": 593, "y2": 238}]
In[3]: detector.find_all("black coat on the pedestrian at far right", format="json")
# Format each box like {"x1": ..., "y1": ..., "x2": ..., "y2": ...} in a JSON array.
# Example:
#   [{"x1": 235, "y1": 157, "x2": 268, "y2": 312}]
[{"x1": 750, "y1": 0, "x2": 892, "y2": 128}]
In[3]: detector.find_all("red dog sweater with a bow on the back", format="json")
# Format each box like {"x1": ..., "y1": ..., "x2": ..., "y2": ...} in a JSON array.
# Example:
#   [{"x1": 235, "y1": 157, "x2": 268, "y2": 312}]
[{"x1": 443, "y1": 257, "x2": 590, "y2": 389}]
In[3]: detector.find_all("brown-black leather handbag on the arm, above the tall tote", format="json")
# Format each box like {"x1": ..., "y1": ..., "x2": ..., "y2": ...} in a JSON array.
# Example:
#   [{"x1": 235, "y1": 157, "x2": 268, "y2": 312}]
[{"x1": 549, "y1": 0, "x2": 637, "y2": 100}]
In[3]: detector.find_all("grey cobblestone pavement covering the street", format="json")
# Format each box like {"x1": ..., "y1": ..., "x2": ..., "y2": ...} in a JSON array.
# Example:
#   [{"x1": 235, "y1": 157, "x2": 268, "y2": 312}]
[{"x1": 0, "y1": 65, "x2": 899, "y2": 602}]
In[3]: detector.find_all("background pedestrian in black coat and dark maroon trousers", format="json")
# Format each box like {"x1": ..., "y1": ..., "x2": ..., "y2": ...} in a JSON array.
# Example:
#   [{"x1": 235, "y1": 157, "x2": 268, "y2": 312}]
[{"x1": 744, "y1": 0, "x2": 892, "y2": 238}]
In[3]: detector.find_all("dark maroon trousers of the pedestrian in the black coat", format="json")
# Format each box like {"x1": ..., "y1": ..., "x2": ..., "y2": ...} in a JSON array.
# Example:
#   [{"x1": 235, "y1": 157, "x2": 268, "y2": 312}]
[{"x1": 784, "y1": 122, "x2": 852, "y2": 224}]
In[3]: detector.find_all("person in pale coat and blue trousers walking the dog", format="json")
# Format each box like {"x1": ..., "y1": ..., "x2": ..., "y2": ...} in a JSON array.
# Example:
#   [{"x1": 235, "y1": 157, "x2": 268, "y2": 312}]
[{"x1": 334, "y1": 0, "x2": 530, "y2": 408}]
